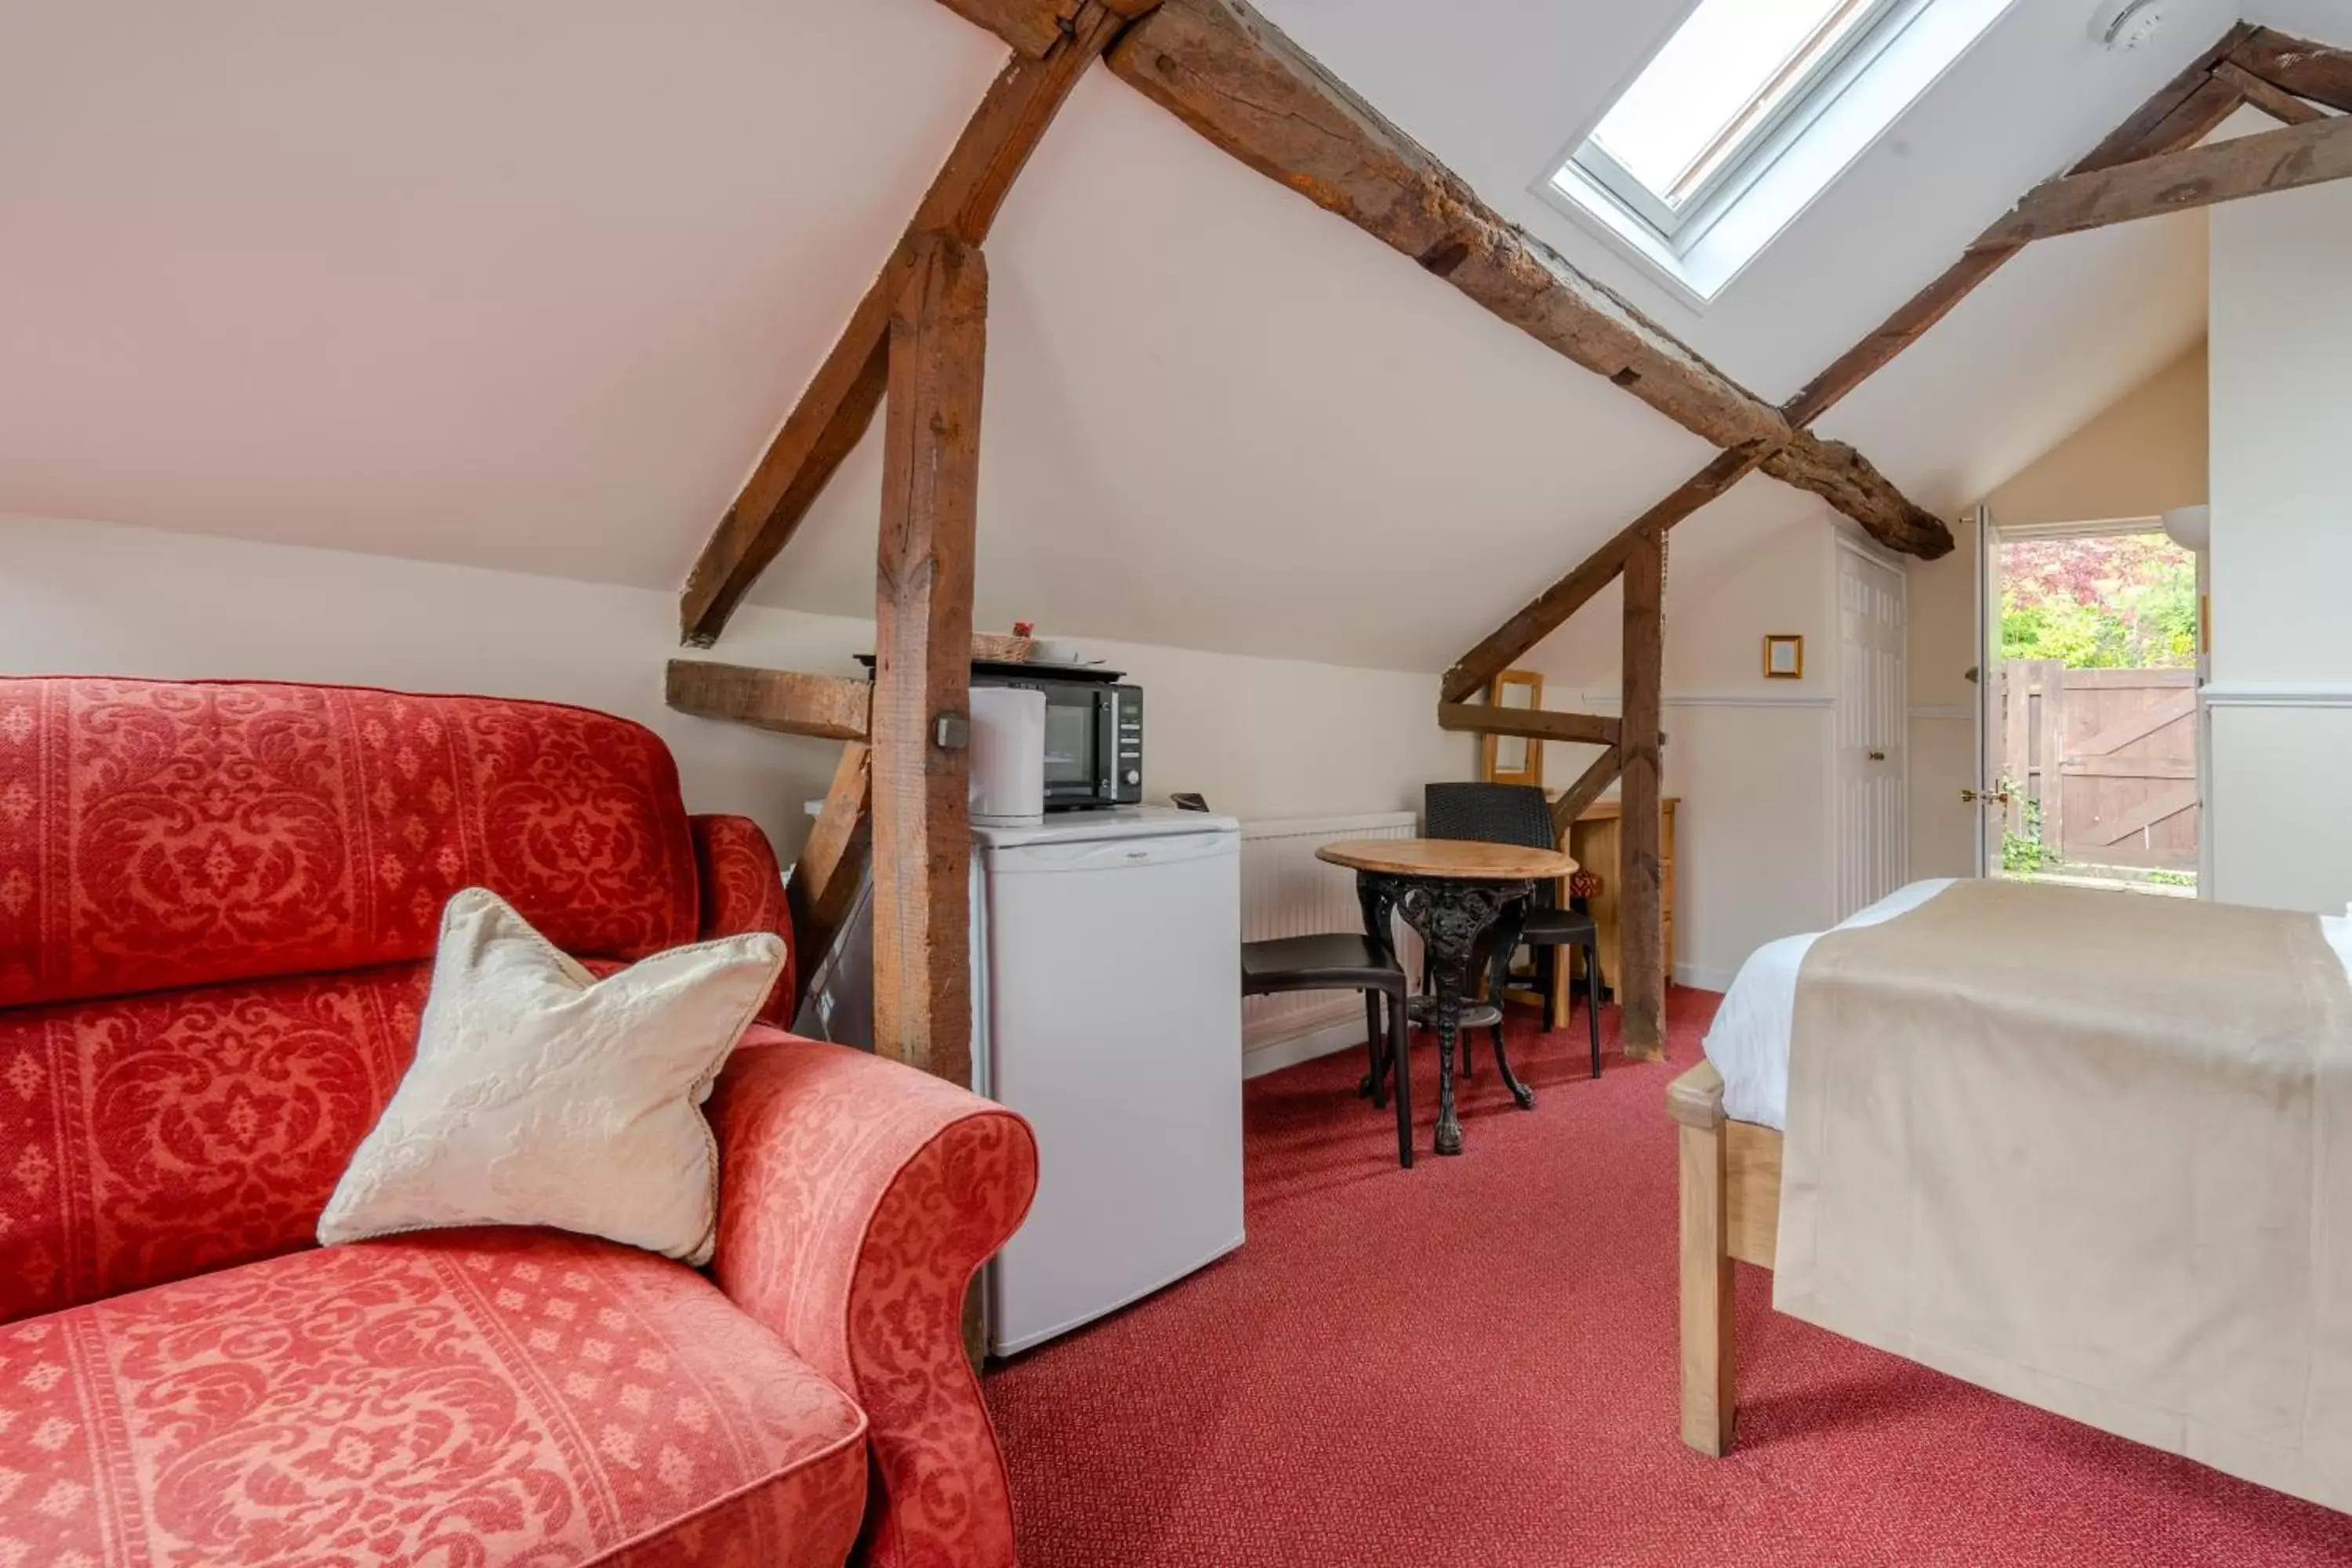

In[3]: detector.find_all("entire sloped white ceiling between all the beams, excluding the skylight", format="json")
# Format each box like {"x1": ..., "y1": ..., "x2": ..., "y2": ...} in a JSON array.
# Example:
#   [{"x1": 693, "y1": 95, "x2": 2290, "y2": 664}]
[{"x1": 0, "y1": 0, "x2": 2338, "y2": 668}]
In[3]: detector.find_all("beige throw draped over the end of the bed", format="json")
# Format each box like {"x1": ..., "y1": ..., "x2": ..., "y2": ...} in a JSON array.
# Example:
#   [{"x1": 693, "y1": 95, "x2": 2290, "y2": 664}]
[{"x1": 1773, "y1": 881, "x2": 2352, "y2": 1512}]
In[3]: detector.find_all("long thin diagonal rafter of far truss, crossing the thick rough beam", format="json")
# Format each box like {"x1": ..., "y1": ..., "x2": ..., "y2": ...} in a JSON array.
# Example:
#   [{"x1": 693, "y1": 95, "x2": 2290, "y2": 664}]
[{"x1": 1439, "y1": 24, "x2": 2277, "y2": 703}]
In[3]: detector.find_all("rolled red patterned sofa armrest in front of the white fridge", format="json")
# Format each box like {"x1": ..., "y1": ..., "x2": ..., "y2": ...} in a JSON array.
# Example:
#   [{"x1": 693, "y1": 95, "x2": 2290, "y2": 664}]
[{"x1": 710, "y1": 1027, "x2": 1037, "y2": 1568}]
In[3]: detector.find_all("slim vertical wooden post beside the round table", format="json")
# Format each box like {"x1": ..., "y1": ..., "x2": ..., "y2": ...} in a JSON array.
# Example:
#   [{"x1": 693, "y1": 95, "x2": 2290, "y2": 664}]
[{"x1": 1618, "y1": 532, "x2": 1665, "y2": 1060}]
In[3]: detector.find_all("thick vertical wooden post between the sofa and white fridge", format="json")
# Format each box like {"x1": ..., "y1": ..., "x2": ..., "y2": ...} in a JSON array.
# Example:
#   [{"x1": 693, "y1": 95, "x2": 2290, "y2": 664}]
[{"x1": 873, "y1": 233, "x2": 988, "y2": 1083}]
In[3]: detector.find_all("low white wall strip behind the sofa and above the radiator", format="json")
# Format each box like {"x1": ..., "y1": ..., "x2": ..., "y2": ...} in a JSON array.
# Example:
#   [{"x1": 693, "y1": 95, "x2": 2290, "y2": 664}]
[{"x1": 0, "y1": 515, "x2": 1475, "y2": 855}]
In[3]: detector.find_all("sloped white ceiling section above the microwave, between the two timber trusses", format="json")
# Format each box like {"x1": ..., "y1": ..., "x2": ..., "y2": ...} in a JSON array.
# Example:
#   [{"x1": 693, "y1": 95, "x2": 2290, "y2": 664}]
[{"x1": 755, "y1": 73, "x2": 1740, "y2": 670}]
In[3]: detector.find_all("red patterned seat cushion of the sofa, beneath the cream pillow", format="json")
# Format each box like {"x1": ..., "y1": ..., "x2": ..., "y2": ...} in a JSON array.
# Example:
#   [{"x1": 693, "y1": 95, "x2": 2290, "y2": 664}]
[{"x1": 0, "y1": 1229, "x2": 866, "y2": 1568}]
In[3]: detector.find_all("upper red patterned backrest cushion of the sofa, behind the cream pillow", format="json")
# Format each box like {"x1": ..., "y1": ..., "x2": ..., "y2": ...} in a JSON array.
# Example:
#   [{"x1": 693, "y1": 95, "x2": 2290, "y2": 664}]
[{"x1": 0, "y1": 680, "x2": 699, "y2": 1006}]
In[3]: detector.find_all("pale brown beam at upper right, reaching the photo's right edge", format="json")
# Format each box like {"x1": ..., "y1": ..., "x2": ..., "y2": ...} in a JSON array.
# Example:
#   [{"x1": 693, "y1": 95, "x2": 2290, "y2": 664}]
[{"x1": 1987, "y1": 115, "x2": 2352, "y2": 245}]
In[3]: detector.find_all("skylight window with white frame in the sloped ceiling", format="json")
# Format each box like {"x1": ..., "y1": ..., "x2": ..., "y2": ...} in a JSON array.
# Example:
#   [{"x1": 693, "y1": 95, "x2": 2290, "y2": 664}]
[{"x1": 1538, "y1": 0, "x2": 2016, "y2": 303}]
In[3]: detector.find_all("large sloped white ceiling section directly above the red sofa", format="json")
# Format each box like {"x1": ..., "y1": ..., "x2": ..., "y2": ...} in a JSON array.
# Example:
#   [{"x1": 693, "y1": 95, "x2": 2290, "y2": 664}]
[{"x1": 0, "y1": 0, "x2": 1004, "y2": 588}]
